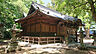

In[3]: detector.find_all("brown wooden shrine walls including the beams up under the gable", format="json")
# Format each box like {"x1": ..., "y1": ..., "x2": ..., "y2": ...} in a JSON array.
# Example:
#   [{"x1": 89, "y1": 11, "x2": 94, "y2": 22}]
[{"x1": 22, "y1": 14, "x2": 76, "y2": 36}]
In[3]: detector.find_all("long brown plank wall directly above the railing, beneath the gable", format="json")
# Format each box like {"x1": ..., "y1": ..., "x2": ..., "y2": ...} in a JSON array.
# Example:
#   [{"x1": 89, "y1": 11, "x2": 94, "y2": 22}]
[{"x1": 22, "y1": 23, "x2": 57, "y2": 35}]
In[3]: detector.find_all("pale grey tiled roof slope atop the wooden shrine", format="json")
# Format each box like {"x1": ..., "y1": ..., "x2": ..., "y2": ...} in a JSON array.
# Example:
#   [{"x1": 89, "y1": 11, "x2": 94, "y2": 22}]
[{"x1": 28, "y1": 1, "x2": 78, "y2": 21}]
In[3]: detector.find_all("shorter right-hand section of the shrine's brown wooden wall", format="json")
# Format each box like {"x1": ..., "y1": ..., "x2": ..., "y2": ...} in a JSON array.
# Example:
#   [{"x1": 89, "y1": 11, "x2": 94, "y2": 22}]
[{"x1": 57, "y1": 22, "x2": 76, "y2": 36}]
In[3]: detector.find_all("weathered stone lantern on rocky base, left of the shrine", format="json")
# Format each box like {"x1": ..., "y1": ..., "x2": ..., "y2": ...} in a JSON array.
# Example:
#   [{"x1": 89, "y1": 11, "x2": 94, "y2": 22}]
[{"x1": 5, "y1": 24, "x2": 22, "y2": 53}]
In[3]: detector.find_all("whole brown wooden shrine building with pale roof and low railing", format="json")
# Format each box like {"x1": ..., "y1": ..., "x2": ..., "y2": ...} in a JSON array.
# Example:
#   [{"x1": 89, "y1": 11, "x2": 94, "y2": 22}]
[{"x1": 16, "y1": 2, "x2": 81, "y2": 44}]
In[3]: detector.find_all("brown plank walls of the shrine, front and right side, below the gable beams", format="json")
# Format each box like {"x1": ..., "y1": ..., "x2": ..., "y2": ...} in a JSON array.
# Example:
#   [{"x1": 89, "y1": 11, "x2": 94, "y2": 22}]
[{"x1": 22, "y1": 20, "x2": 76, "y2": 36}]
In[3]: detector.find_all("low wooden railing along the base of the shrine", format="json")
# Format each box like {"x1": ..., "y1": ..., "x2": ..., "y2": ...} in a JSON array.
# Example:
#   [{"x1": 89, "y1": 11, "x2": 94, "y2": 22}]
[{"x1": 22, "y1": 36, "x2": 62, "y2": 44}]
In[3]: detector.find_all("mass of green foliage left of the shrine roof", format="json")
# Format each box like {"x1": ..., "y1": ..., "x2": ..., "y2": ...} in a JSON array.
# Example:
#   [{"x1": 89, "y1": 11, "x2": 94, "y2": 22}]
[{"x1": 0, "y1": 0, "x2": 36, "y2": 38}]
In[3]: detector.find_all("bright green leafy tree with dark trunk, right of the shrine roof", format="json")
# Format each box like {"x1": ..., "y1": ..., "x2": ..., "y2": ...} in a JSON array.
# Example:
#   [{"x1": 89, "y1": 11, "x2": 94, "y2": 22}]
[{"x1": 52, "y1": 0, "x2": 96, "y2": 37}]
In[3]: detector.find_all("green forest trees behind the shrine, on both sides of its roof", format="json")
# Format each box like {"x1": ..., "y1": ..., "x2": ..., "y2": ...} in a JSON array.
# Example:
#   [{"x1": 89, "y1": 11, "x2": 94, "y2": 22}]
[{"x1": 0, "y1": 0, "x2": 96, "y2": 38}]
